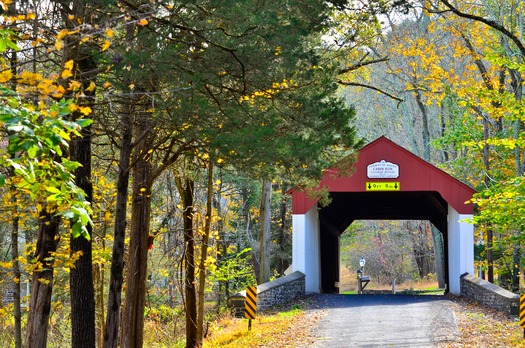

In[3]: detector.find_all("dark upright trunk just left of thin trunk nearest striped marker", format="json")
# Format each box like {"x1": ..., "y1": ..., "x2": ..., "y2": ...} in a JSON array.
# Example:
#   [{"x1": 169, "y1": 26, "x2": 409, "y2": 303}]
[{"x1": 176, "y1": 178, "x2": 199, "y2": 348}]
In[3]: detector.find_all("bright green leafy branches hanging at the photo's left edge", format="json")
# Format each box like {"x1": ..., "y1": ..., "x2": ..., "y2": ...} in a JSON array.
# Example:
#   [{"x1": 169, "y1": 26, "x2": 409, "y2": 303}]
[{"x1": 0, "y1": 82, "x2": 92, "y2": 238}]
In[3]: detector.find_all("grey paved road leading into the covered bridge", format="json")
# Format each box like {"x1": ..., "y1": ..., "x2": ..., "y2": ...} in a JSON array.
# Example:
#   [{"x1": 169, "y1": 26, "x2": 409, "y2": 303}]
[{"x1": 314, "y1": 294, "x2": 458, "y2": 348}]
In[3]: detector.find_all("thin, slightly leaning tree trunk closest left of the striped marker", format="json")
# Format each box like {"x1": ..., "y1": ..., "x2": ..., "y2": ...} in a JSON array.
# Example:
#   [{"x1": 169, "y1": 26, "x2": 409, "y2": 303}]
[{"x1": 197, "y1": 162, "x2": 213, "y2": 346}]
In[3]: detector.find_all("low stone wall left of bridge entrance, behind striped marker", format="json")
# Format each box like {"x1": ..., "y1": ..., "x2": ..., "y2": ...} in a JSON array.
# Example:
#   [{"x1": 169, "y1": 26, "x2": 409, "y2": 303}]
[{"x1": 230, "y1": 272, "x2": 306, "y2": 317}]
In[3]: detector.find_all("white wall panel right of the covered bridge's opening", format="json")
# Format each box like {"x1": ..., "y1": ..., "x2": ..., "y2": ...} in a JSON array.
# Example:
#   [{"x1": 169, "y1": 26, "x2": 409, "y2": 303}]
[{"x1": 447, "y1": 204, "x2": 474, "y2": 295}]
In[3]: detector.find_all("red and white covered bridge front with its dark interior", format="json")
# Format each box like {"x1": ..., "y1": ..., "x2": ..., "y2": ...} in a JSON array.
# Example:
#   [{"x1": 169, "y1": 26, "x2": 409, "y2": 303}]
[{"x1": 291, "y1": 137, "x2": 475, "y2": 294}]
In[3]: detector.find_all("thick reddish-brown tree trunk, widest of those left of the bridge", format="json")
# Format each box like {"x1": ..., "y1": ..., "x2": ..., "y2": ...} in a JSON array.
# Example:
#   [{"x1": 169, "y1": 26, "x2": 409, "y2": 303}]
[{"x1": 122, "y1": 139, "x2": 152, "y2": 348}]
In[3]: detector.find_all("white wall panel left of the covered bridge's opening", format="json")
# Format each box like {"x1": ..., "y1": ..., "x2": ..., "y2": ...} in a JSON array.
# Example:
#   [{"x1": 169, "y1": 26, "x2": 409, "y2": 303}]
[{"x1": 292, "y1": 205, "x2": 321, "y2": 293}]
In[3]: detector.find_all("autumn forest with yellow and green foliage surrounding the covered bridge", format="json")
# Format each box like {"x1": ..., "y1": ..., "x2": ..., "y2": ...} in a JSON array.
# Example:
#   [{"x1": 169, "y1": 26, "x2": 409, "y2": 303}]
[{"x1": 0, "y1": 0, "x2": 525, "y2": 347}]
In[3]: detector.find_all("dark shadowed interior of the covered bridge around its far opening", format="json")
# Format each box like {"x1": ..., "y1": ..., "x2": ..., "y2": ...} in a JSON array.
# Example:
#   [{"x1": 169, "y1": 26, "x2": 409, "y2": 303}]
[{"x1": 319, "y1": 191, "x2": 448, "y2": 293}]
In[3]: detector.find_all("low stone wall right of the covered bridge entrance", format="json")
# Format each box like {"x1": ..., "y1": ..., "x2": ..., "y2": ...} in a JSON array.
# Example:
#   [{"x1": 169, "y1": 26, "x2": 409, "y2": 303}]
[{"x1": 461, "y1": 273, "x2": 520, "y2": 314}]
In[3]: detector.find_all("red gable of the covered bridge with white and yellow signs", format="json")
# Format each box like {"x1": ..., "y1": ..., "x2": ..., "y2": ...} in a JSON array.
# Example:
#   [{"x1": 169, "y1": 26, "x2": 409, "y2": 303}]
[{"x1": 291, "y1": 136, "x2": 476, "y2": 215}]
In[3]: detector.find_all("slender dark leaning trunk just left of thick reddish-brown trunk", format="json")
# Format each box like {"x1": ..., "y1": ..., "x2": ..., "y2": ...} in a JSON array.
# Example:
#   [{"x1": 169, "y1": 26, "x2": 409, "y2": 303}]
[{"x1": 104, "y1": 102, "x2": 133, "y2": 348}]
